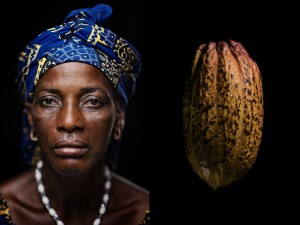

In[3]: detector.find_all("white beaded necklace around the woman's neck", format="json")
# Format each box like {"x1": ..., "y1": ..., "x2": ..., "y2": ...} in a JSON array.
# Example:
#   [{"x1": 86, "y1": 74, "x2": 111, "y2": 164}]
[{"x1": 35, "y1": 161, "x2": 111, "y2": 225}]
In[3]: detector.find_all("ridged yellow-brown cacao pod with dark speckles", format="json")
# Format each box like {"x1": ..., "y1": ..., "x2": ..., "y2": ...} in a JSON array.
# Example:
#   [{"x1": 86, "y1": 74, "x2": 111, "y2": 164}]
[{"x1": 183, "y1": 40, "x2": 264, "y2": 191}]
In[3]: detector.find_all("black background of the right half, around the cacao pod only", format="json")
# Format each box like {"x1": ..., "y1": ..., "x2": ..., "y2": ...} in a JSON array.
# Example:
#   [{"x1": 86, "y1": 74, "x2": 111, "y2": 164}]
[{"x1": 149, "y1": 1, "x2": 299, "y2": 224}]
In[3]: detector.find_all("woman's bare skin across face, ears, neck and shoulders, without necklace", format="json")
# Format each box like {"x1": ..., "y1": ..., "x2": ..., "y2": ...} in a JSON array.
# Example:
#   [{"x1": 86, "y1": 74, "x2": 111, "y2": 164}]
[{"x1": 0, "y1": 62, "x2": 149, "y2": 225}]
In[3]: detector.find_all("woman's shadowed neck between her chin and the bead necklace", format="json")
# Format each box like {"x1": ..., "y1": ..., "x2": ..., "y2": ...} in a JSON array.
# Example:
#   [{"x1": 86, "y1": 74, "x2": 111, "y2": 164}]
[{"x1": 42, "y1": 162, "x2": 104, "y2": 213}]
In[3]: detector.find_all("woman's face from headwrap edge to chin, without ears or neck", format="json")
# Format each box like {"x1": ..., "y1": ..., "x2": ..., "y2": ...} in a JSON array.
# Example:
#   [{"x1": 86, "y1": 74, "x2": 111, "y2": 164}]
[{"x1": 29, "y1": 62, "x2": 122, "y2": 175}]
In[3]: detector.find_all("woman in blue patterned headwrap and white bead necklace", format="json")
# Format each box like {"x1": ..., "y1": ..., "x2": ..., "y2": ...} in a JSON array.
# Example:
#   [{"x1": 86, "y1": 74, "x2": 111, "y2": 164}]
[{"x1": 0, "y1": 4, "x2": 149, "y2": 225}]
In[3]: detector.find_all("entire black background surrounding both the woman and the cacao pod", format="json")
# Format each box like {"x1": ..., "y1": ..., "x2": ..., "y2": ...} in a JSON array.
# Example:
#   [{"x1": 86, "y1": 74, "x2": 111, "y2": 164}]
[{"x1": 0, "y1": 0, "x2": 299, "y2": 224}]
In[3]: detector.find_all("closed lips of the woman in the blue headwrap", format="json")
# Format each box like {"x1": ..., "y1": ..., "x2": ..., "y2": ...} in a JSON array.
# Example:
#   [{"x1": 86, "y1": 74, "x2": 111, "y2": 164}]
[{"x1": 52, "y1": 140, "x2": 89, "y2": 158}]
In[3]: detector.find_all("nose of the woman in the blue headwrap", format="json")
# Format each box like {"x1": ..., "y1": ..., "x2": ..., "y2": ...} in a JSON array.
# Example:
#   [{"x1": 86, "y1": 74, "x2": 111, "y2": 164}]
[{"x1": 57, "y1": 100, "x2": 84, "y2": 133}]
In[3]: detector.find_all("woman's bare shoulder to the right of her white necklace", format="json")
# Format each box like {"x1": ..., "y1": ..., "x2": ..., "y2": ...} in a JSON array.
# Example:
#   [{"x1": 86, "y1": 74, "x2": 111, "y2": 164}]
[{"x1": 110, "y1": 173, "x2": 149, "y2": 224}]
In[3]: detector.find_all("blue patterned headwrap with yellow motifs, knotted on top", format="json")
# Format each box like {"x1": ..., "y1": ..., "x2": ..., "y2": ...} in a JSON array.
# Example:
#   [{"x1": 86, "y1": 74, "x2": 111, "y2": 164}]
[{"x1": 16, "y1": 4, "x2": 141, "y2": 161}]
